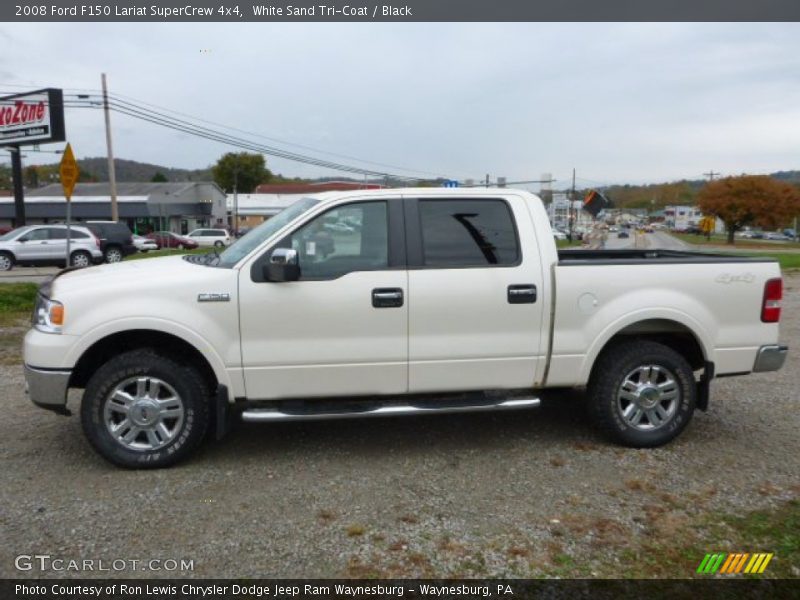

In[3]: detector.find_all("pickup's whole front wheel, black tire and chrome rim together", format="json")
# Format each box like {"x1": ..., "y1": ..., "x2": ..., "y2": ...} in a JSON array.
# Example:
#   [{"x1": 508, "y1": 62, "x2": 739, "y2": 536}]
[{"x1": 81, "y1": 350, "x2": 210, "y2": 469}]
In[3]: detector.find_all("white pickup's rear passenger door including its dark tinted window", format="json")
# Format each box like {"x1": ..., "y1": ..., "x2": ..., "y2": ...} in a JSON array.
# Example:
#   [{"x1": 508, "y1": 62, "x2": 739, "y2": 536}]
[{"x1": 406, "y1": 195, "x2": 543, "y2": 393}]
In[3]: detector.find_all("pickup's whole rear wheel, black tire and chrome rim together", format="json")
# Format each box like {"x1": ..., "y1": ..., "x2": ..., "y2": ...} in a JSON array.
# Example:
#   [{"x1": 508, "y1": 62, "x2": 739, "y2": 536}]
[{"x1": 588, "y1": 340, "x2": 697, "y2": 448}]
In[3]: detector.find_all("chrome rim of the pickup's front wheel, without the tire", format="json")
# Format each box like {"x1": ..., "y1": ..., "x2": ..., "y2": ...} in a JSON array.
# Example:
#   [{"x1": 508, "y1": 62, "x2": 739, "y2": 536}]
[{"x1": 103, "y1": 377, "x2": 184, "y2": 451}]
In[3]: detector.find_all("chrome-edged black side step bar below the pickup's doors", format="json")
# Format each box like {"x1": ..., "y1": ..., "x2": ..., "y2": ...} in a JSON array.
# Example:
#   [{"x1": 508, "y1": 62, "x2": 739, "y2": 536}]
[{"x1": 242, "y1": 398, "x2": 541, "y2": 423}]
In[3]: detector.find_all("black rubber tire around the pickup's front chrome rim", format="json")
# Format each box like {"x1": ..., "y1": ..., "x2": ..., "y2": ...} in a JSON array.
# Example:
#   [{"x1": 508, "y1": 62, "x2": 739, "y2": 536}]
[{"x1": 81, "y1": 349, "x2": 211, "y2": 469}]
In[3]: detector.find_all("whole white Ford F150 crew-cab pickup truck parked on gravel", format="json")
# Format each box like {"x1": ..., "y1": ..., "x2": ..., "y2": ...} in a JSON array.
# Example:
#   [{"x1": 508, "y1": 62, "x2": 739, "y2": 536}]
[{"x1": 20, "y1": 188, "x2": 787, "y2": 467}]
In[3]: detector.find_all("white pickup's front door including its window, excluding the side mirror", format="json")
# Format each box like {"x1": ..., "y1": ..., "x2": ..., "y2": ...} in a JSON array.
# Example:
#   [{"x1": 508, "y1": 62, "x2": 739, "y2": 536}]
[{"x1": 239, "y1": 198, "x2": 408, "y2": 399}]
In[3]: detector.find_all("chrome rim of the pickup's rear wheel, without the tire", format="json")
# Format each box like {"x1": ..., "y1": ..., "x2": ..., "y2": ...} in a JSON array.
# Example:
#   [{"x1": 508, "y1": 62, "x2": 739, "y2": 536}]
[{"x1": 617, "y1": 365, "x2": 681, "y2": 431}]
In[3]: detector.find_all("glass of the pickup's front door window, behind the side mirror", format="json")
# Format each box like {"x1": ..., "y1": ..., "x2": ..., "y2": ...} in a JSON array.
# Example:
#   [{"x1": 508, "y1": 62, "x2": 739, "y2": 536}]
[{"x1": 280, "y1": 202, "x2": 389, "y2": 279}]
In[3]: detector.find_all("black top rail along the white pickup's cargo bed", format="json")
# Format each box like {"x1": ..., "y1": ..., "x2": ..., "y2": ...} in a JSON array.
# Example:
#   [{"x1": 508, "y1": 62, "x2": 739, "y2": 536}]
[{"x1": 558, "y1": 248, "x2": 776, "y2": 266}]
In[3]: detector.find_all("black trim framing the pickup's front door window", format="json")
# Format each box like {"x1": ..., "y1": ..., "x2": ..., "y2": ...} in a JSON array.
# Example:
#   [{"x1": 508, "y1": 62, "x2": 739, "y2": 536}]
[{"x1": 250, "y1": 198, "x2": 408, "y2": 283}]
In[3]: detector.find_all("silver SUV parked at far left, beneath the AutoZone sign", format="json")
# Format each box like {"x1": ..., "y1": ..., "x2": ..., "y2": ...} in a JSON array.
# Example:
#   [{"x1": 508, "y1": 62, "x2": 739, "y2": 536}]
[{"x1": 0, "y1": 225, "x2": 103, "y2": 271}]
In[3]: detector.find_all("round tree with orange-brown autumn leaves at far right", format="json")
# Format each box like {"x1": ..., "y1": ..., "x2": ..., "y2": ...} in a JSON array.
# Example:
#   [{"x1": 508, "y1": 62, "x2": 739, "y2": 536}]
[{"x1": 697, "y1": 175, "x2": 800, "y2": 244}]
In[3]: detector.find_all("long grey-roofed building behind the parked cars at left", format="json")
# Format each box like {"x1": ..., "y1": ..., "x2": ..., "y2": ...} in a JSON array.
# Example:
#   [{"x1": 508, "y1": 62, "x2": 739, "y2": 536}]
[{"x1": 0, "y1": 182, "x2": 227, "y2": 233}]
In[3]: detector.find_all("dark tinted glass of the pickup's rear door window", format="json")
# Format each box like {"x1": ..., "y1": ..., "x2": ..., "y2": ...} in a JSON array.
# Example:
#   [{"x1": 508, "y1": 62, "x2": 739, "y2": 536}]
[{"x1": 419, "y1": 200, "x2": 519, "y2": 267}]
